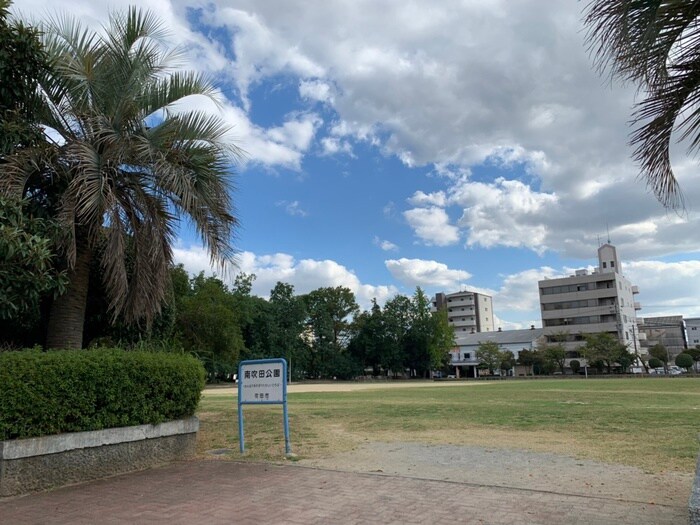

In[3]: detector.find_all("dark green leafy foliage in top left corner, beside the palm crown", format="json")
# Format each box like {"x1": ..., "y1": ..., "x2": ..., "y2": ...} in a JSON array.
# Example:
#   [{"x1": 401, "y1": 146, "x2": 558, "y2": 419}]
[{"x1": 0, "y1": 0, "x2": 47, "y2": 156}]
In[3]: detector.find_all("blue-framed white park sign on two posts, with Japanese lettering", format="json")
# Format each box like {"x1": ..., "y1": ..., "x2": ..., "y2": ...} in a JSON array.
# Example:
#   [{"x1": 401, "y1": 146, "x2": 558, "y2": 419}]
[{"x1": 238, "y1": 358, "x2": 292, "y2": 454}]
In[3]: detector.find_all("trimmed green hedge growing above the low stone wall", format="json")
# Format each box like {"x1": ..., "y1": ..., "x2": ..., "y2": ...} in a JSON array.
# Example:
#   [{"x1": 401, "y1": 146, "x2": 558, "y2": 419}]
[{"x1": 0, "y1": 350, "x2": 204, "y2": 440}]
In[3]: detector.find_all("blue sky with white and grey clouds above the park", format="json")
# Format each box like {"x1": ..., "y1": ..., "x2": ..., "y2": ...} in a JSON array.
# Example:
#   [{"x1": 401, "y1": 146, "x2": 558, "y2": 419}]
[{"x1": 13, "y1": 0, "x2": 700, "y2": 330}]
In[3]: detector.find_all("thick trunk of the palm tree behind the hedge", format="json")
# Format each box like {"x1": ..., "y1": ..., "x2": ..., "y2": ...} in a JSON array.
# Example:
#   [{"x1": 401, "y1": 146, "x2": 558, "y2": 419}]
[{"x1": 46, "y1": 244, "x2": 92, "y2": 349}]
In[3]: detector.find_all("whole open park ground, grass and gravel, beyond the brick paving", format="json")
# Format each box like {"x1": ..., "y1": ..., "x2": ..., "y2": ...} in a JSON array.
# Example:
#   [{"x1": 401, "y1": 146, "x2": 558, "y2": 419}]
[{"x1": 198, "y1": 378, "x2": 700, "y2": 506}]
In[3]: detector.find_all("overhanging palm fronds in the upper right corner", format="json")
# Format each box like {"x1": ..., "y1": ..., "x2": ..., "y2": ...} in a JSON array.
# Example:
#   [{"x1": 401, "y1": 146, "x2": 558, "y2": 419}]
[{"x1": 585, "y1": 0, "x2": 700, "y2": 209}]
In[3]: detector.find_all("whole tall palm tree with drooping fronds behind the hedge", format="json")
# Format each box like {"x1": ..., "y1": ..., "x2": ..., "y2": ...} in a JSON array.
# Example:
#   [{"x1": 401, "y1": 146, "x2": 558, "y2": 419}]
[{"x1": 0, "y1": 8, "x2": 240, "y2": 348}]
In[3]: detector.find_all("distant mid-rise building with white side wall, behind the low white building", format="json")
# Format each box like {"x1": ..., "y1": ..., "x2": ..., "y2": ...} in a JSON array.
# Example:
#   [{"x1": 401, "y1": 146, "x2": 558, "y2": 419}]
[{"x1": 433, "y1": 291, "x2": 494, "y2": 337}]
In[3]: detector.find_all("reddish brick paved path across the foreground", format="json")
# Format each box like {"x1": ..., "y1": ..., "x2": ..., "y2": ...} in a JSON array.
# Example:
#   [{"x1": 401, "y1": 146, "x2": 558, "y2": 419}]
[{"x1": 0, "y1": 460, "x2": 688, "y2": 525}]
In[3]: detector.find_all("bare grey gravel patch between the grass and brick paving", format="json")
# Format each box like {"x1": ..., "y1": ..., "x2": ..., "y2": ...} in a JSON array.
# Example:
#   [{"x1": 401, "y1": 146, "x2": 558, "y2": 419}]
[{"x1": 300, "y1": 442, "x2": 693, "y2": 507}]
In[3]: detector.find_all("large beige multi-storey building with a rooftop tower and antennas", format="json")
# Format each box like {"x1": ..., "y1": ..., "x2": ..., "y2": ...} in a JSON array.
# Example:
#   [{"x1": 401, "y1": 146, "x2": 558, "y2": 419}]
[{"x1": 538, "y1": 243, "x2": 641, "y2": 357}]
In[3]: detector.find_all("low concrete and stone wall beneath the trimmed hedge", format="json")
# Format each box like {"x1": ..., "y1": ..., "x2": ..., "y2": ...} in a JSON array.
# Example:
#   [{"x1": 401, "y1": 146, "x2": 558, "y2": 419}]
[{"x1": 0, "y1": 417, "x2": 199, "y2": 496}]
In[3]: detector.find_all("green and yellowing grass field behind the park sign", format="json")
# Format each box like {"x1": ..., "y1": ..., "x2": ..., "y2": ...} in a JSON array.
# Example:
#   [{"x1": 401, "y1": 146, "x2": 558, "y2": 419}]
[{"x1": 198, "y1": 378, "x2": 700, "y2": 472}]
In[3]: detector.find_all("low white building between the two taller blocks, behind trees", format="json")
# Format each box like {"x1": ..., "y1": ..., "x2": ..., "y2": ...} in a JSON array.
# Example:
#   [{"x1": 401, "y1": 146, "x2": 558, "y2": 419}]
[{"x1": 450, "y1": 326, "x2": 544, "y2": 377}]
